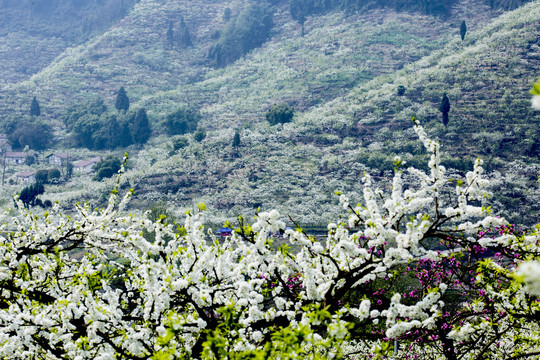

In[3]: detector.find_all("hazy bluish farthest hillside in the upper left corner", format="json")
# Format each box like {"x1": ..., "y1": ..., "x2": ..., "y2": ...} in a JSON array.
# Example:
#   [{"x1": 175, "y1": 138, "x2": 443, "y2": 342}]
[{"x1": 0, "y1": 0, "x2": 135, "y2": 84}]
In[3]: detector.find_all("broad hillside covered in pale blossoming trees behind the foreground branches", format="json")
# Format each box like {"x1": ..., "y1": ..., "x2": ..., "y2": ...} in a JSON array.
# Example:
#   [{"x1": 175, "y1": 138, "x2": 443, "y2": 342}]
[{"x1": 0, "y1": 0, "x2": 540, "y2": 225}]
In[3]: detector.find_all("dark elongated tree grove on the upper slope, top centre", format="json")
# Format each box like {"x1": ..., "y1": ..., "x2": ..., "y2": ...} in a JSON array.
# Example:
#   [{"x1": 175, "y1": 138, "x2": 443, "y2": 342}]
[{"x1": 208, "y1": 0, "x2": 275, "y2": 67}]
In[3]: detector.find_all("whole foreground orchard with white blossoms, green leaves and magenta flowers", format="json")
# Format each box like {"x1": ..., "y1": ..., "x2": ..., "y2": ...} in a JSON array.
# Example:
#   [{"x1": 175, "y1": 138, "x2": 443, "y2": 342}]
[{"x1": 0, "y1": 116, "x2": 540, "y2": 360}]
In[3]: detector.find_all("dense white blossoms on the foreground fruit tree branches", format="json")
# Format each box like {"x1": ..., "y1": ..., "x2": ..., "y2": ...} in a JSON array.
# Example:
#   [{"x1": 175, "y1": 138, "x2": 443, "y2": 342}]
[{"x1": 0, "y1": 125, "x2": 540, "y2": 359}]
